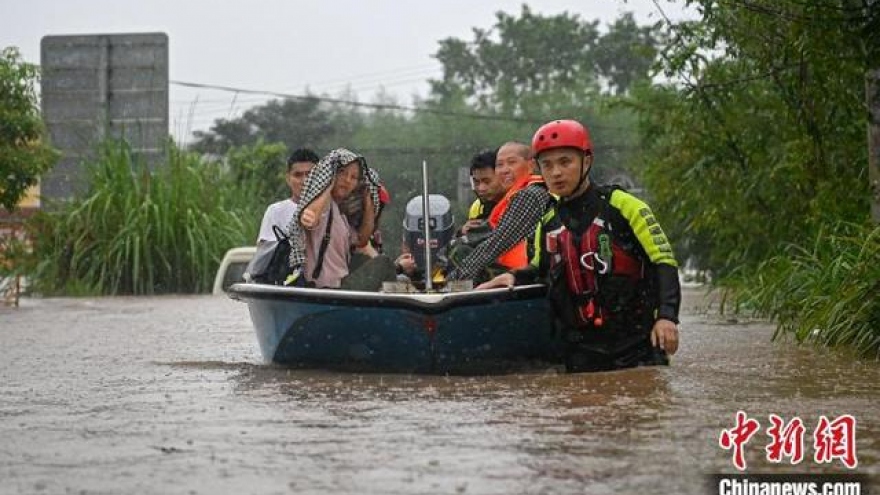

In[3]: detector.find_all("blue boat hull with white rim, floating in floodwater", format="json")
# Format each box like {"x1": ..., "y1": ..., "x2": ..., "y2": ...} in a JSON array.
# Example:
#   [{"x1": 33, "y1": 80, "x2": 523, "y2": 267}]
[{"x1": 229, "y1": 284, "x2": 557, "y2": 374}]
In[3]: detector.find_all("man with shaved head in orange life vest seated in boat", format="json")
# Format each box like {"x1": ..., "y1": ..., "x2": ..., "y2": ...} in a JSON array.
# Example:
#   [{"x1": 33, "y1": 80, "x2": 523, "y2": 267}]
[{"x1": 448, "y1": 141, "x2": 550, "y2": 280}]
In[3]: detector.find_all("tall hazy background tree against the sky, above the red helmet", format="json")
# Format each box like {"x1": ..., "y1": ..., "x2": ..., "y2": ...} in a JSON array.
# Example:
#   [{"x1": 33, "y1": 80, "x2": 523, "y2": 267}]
[{"x1": 431, "y1": 5, "x2": 658, "y2": 115}]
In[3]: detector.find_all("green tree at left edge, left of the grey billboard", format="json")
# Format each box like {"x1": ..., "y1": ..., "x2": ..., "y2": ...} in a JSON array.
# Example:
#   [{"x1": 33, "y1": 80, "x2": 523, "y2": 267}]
[{"x1": 0, "y1": 47, "x2": 58, "y2": 211}]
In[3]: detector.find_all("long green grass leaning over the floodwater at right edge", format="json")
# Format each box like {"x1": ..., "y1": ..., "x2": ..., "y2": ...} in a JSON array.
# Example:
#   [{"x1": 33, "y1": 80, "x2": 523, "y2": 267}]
[{"x1": 740, "y1": 223, "x2": 880, "y2": 359}]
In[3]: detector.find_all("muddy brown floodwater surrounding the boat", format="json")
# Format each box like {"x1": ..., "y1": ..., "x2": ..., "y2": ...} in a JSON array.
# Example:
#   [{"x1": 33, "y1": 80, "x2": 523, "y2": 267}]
[{"x1": 0, "y1": 291, "x2": 880, "y2": 494}]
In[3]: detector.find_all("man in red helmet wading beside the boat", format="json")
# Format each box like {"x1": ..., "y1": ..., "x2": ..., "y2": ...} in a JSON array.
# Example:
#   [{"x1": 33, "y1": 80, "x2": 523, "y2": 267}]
[{"x1": 478, "y1": 120, "x2": 681, "y2": 372}]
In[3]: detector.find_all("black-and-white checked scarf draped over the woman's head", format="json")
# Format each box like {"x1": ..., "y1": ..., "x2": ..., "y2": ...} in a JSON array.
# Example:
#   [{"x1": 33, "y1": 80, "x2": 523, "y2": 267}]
[{"x1": 287, "y1": 148, "x2": 381, "y2": 270}]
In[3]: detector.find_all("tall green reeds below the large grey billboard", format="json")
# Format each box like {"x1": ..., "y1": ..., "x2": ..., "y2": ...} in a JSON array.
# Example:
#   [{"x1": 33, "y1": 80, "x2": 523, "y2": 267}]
[{"x1": 31, "y1": 141, "x2": 255, "y2": 294}]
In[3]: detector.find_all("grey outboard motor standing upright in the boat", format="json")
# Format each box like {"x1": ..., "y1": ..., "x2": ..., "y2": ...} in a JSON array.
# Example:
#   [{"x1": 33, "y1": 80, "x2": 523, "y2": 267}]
[{"x1": 403, "y1": 194, "x2": 455, "y2": 268}]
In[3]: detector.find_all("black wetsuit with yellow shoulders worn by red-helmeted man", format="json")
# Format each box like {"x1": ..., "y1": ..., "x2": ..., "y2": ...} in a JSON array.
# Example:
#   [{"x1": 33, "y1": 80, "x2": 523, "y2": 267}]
[{"x1": 514, "y1": 186, "x2": 681, "y2": 372}]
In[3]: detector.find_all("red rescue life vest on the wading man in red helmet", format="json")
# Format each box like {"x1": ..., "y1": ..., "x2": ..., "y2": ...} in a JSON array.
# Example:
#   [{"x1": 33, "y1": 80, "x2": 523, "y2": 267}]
[{"x1": 545, "y1": 195, "x2": 646, "y2": 328}]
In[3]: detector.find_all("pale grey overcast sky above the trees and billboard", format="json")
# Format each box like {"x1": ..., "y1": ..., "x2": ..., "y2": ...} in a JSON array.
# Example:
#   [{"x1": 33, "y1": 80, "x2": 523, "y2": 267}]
[{"x1": 0, "y1": 0, "x2": 686, "y2": 141}]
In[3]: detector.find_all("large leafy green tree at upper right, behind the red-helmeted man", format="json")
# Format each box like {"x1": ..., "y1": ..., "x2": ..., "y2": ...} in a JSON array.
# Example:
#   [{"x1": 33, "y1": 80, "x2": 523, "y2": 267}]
[{"x1": 638, "y1": 0, "x2": 871, "y2": 275}]
